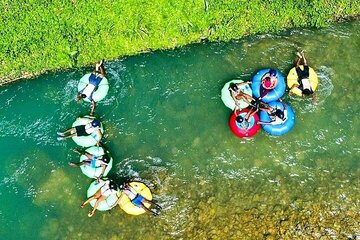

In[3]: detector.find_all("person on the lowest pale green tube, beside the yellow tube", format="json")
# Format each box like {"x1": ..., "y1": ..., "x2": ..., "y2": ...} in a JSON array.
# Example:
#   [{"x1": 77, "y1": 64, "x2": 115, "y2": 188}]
[{"x1": 80, "y1": 179, "x2": 118, "y2": 217}]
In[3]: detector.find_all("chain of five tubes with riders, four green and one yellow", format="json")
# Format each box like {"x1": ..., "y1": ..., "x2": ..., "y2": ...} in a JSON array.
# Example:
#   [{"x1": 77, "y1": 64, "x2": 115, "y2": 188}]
[{"x1": 58, "y1": 60, "x2": 161, "y2": 217}]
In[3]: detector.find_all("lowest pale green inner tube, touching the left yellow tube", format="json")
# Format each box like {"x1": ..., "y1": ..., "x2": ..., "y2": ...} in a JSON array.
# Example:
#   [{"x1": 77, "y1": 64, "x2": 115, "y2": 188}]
[{"x1": 87, "y1": 180, "x2": 120, "y2": 211}]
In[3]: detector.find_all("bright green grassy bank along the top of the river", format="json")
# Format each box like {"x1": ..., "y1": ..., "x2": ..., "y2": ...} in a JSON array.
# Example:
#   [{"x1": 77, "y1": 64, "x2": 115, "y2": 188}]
[{"x1": 0, "y1": 0, "x2": 360, "y2": 86}]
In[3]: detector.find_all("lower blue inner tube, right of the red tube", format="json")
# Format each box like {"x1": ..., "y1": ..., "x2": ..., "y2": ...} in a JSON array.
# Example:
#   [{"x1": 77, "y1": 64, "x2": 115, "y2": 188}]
[{"x1": 260, "y1": 101, "x2": 295, "y2": 136}]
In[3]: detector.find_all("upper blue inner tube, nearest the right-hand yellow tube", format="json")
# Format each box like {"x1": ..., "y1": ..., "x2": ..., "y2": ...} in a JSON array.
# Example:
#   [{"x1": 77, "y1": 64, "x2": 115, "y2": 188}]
[{"x1": 251, "y1": 68, "x2": 286, "y2": 103}]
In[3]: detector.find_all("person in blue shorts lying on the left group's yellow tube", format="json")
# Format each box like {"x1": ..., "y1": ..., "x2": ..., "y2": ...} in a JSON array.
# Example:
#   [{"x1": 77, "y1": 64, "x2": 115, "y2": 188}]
[{"x1": 119, "y1": 183, "x2": 161, "y2": 216}]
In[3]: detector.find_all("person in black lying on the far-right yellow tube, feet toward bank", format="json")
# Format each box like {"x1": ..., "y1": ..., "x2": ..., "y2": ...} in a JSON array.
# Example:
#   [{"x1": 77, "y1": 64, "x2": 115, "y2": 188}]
[{"x1": 290, "y1": 51, "x2": 316, "y2": 101}]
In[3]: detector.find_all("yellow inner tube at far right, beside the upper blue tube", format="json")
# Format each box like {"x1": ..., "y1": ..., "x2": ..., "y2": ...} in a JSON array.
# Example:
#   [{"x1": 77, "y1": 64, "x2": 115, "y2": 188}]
[{"x1": 287, "y1": 65, "x2": 319, "y2": 96}]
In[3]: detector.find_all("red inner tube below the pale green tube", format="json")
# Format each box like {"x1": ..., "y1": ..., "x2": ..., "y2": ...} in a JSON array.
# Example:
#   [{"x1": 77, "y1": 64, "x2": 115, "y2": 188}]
[{"x1": 229, "y1": 108, "x2": 260, "y2": 138}]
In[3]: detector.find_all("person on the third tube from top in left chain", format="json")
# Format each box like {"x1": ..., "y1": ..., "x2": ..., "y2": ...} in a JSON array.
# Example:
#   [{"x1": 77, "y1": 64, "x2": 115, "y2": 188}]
[{"x1": 69, "y1": 149, "x2": 111, "y2": 179}]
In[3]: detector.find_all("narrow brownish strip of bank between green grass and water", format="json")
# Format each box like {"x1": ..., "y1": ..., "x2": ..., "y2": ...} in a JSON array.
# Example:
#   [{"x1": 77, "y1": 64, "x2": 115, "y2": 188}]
[{"x1": 0, "y1": 13, "x2": 360, "y2": 87}]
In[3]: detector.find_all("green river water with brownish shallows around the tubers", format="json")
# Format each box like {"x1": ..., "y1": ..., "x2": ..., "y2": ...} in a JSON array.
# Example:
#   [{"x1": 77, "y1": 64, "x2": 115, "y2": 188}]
[{"x1": 0, "y1": 21, "x2": 360, "y2": 239}]
